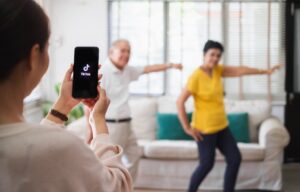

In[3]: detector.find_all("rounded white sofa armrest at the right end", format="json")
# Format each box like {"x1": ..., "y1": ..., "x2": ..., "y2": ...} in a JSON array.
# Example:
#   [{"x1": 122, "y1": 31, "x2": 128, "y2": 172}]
[{"x1": 259, "y1": 117, "x2": 290, "y2": 160}]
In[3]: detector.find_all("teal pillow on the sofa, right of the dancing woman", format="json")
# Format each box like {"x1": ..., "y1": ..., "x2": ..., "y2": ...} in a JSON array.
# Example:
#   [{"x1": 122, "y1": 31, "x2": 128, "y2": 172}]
[{"x1": 227, "y1": 113, "x2": 250, "y2": 143}]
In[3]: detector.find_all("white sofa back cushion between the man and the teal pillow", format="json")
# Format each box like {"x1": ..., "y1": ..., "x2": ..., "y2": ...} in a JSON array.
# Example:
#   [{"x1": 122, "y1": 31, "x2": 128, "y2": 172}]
[{"x1": 129, "y1": 98, "x2": 157, "y2": 140}]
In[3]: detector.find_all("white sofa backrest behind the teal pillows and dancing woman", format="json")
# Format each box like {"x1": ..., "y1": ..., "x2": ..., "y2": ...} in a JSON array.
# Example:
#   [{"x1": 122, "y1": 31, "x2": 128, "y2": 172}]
[{"x1": 129, "y1": 96, "x2": 271, "y2": 142}]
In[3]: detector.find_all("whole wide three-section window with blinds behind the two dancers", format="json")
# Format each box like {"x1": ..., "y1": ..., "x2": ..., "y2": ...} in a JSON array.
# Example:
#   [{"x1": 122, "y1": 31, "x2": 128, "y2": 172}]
[{"x1": 109, "y1": 0, "x2": 285, "y2": 99}]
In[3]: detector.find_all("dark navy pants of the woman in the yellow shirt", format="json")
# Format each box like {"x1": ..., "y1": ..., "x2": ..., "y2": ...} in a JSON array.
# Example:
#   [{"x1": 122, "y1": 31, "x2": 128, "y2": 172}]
[{"x1": 188, "y1": 128, "x2": 241, "y2": 192}]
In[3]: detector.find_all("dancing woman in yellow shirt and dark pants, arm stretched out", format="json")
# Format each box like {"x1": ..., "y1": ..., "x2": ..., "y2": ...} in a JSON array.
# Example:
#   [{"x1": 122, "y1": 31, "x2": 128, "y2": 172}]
[{"x1": 177, "y1": 40, "x2": 280, "y2": 192}]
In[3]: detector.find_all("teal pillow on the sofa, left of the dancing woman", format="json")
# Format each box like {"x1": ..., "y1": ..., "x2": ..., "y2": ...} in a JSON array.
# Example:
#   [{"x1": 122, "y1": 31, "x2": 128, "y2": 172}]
[{"x1": 156, "y1": 113, "x2": 193, "y2": 140}]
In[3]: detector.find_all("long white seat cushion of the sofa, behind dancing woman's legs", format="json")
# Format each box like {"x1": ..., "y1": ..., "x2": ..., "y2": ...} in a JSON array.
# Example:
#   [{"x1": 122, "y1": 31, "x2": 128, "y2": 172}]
[{"x1": 143, "y1": 140, "x2": 264, "y2": 161}]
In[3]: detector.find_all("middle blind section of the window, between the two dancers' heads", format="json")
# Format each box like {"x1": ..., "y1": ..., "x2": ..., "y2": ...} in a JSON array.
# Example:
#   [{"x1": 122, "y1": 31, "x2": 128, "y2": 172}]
[{"x1": 167, "y1": 2, "x2": 222, "y2": 95}]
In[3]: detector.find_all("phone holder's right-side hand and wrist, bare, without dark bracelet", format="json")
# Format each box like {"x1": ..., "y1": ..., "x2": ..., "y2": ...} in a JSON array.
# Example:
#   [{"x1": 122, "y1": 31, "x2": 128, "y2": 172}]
[{"x1": 89, "y1": 86, "x2": 110, "y2": 138}]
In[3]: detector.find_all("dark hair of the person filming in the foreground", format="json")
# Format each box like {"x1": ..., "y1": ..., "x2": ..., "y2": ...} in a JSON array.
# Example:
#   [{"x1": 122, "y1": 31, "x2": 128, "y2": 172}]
[{"x1": 0, "y1": 0, "x2": 50, "y2": 82}]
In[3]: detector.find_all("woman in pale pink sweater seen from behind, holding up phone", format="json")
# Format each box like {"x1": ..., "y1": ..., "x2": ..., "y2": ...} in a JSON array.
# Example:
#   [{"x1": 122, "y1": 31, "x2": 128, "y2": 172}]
[{"x1": 0, "y1": 0, "x2": 132, "y2": 192}]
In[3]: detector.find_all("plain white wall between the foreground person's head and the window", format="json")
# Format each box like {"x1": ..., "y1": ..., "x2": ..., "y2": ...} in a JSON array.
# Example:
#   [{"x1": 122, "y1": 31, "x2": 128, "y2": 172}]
[{"x1": 41, "y1": 0, "x2": 108, "y2": 100}]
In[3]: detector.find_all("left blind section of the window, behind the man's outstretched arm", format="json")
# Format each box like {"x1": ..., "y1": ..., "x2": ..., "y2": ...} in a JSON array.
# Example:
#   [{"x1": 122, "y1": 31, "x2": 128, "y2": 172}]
[{"x1": 110, "y1": 1, "x2": 164, "y2": 94}]
